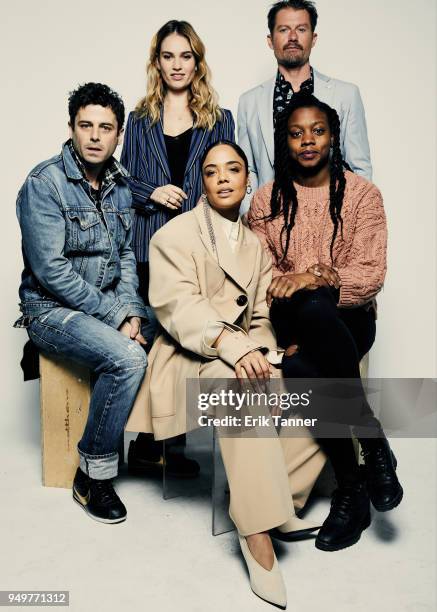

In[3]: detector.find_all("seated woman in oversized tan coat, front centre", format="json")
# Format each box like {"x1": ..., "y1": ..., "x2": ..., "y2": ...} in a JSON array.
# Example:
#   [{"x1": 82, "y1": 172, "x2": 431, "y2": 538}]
[{"x1": 127, "y1": 141, "x2": 324, "y2": 607}]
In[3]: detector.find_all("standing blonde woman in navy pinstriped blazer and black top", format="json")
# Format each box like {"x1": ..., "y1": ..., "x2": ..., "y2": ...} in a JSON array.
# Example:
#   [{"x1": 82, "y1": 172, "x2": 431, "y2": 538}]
[{"x1": 121, "y1": 20, "x2": 235, "y2": 477}]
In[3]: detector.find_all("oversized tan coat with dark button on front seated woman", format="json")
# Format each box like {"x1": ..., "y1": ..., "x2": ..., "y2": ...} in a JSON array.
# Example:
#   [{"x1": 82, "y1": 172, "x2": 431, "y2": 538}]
[{"x1": 126, "y1": 203, "x2": 276, "y2": 440}]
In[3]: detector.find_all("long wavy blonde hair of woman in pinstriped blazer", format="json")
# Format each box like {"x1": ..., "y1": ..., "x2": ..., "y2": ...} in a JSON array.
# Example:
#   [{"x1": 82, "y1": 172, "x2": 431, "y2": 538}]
[{"x1": 135, "y1": 19, "x2": 222, "y2": 130}]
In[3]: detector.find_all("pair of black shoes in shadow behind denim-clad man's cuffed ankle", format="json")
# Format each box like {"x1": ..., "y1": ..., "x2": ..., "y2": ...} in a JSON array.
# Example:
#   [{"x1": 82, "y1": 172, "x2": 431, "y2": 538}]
[{"x1": 127, "y1": 440, "x2": 200, "y2": 478}]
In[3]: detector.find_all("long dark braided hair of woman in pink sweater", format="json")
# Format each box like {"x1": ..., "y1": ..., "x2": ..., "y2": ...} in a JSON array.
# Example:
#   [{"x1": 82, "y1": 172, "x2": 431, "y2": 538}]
[{"x1": 266, "y1": 92, "x2": 350, "y2": 264}]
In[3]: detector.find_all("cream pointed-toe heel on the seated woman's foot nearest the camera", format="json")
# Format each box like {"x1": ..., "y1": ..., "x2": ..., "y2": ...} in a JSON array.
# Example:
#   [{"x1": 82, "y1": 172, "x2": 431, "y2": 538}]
[{"x1": 238, "y1": 534, "x2": 287, "y2": 610}]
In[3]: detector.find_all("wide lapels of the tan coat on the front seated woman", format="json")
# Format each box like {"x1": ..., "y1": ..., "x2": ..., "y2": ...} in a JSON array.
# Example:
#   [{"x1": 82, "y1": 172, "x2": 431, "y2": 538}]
[{"x1": 193, "y1": 199, "x2": 257, "y2": 290}]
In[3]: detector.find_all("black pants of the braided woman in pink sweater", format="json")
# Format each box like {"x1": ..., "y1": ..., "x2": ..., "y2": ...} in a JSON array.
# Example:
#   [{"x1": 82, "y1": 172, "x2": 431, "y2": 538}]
[{"x1": 270, "y1": 287, "x2": 379, "y2": 481}]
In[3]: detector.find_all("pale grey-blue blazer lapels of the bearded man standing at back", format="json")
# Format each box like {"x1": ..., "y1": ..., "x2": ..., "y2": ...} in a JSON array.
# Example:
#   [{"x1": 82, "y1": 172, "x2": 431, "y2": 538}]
[{"x1": 259, "y1": 68, "x2": 334, "y2": 167}]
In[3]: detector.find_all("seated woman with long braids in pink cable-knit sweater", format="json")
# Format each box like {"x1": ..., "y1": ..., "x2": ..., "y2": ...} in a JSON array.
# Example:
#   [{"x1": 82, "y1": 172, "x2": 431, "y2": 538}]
[{"x1": 248, "y1": 93, "x2": 403, "y2": 551}]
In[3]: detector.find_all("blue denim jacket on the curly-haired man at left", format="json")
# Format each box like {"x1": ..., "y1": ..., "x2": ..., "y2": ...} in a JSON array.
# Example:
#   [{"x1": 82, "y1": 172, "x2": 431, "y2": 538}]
[{"x1": 16, "y1": 143, "x2": 147, "y2": 329}]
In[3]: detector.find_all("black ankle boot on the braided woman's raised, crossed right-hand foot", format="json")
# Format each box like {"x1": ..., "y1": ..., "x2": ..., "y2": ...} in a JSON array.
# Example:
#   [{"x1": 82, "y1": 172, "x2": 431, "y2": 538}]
[{"x1": 360, "y1": 430, "x2": 404, "y2": 512}]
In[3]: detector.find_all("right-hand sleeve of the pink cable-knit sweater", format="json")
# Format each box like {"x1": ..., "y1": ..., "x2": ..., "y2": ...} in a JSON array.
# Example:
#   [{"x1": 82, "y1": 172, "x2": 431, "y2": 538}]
[{"x1": 337, "y1": 185, "x2": 387, "y2": 307}]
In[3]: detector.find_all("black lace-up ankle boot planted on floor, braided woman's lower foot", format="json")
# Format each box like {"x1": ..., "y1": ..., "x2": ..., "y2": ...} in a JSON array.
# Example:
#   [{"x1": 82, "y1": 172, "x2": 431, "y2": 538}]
[{"x1": 315, "y1": 475, "x2": 371, "y2": 551}]
